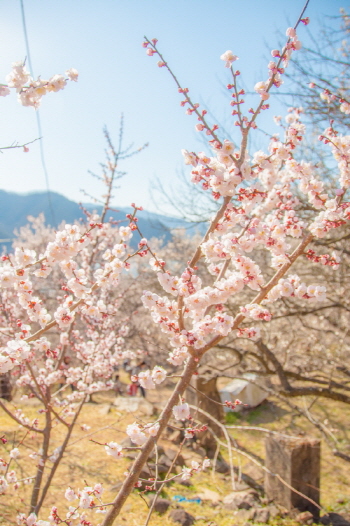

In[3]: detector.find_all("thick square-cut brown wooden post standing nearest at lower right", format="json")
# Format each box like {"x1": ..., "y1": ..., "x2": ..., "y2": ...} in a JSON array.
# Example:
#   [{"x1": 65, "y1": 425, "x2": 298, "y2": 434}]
[{"x1": 265, "y1": 435, "x2": 321, "y2": 519}]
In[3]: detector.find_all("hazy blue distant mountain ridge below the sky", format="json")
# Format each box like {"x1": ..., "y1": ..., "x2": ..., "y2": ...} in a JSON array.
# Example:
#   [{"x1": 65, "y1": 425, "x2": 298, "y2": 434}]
[{"x1": 0, "y1": 190, "x2": 202, "y2": 248}]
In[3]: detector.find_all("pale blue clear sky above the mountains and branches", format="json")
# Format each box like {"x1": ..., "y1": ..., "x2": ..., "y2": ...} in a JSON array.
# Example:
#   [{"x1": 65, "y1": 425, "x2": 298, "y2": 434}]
[{"x1": 0, "y1": 0, "x2": 349, "y2": 217}]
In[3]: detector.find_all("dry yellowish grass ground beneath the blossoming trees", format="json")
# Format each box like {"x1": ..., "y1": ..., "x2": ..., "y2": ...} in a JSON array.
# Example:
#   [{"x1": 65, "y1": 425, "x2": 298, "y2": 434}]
[{"x1": 0, "y1": 393, "x2": 350, "y2": 526}]
